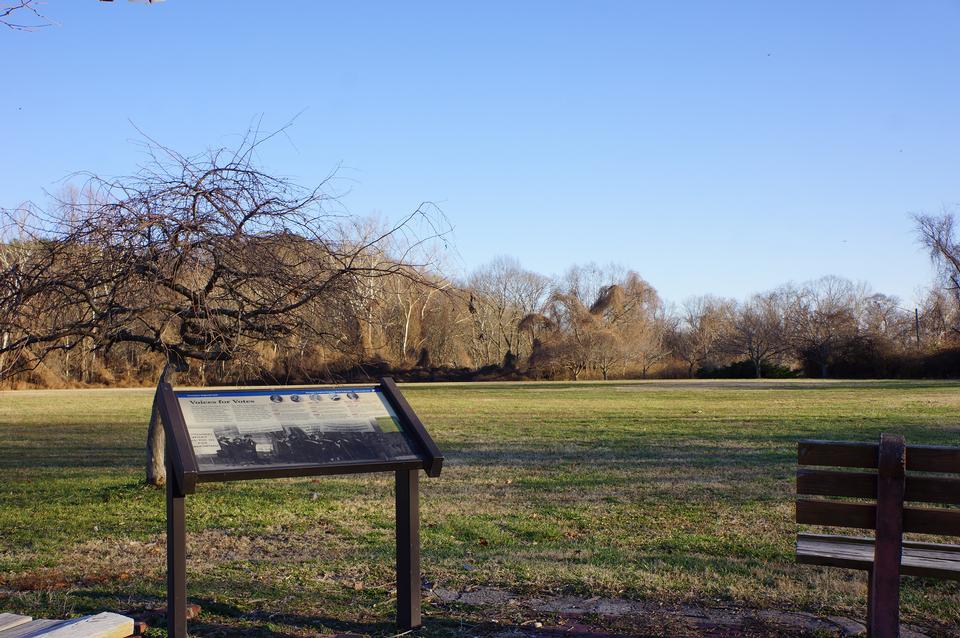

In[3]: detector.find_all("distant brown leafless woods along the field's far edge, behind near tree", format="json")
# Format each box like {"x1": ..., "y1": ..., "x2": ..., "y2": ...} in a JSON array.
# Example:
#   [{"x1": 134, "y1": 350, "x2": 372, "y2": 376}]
[{"x1": 0, "y1": 258, "x2": 960, "y2": 387}]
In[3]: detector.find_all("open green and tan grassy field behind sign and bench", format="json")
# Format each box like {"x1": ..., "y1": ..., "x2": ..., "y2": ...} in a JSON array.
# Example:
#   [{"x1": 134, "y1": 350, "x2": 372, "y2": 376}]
[{"x1": 0, "y1": 381, "x2": 960, "y2": 636}]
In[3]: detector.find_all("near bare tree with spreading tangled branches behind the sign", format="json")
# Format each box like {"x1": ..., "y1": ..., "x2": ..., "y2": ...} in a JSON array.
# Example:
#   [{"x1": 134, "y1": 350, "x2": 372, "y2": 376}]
[{"x1": 0, "y1": 131, "x2": 446, "y2": 484}]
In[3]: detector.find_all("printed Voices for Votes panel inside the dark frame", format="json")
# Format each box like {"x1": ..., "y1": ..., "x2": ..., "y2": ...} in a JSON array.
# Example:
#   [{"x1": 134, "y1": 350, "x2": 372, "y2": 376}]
[{"x1": 177, "y1": 388, "x2": 418, "y2": 472}]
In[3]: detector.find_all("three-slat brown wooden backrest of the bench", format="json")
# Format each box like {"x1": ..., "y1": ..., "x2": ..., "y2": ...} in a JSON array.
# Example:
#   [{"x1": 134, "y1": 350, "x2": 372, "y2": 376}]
[{"x1": 797, "y1": 435, "x2": 960, "y2": 536}]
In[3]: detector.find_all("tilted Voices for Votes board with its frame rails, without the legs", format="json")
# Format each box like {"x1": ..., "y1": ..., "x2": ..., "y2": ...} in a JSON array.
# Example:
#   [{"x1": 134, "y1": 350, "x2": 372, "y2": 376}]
[{"x1": 158, "y1": 379, "x2": 443, "y2": 493}]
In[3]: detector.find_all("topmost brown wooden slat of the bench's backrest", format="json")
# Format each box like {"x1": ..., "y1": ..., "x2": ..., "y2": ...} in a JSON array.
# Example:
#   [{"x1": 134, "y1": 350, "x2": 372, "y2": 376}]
[{"x1": 797, "y1": 441, "x2": 960, "y2": 474}]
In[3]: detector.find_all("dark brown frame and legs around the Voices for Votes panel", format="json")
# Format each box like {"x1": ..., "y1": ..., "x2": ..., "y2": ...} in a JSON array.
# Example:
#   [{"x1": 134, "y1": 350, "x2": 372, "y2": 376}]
[{"x1": 156, "y1": 377, "x2": 443, "y2": 638}]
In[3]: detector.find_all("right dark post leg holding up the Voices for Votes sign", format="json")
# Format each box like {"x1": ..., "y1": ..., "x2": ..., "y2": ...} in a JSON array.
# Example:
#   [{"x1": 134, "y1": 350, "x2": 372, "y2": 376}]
[{"x1": 397, "y1": 470, "x2": 421, "y2": 631}]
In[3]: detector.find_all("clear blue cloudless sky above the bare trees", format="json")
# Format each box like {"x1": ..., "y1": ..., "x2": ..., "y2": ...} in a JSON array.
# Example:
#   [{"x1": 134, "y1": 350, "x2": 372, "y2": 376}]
[{"x1": 0, "y1": 0, "x2": 960, "y2": 305}]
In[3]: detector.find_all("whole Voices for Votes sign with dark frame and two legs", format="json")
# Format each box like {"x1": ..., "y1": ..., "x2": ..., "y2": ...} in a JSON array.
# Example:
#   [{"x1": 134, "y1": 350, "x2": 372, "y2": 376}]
[{"x1": 155, "y1": 378, "x2": 443, "y2": 638}]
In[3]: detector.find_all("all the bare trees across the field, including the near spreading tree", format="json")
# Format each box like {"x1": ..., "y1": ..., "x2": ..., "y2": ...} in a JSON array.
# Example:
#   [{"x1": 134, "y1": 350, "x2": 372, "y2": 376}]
[{"x1": 0, "y1": 132, "x2": 960, "y2": 387}]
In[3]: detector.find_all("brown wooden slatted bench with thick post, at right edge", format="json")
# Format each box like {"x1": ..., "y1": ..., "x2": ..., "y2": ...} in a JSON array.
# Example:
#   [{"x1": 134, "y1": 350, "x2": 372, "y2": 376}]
[{"x1": 797, "y1": 434, "x2": 960, "y2": 638}]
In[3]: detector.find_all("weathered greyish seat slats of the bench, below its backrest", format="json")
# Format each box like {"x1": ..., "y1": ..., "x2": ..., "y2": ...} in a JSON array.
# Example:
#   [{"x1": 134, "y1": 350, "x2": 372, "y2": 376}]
[{"x1": 797, "y1": 534, "x2": 960, "y2": 580}]
